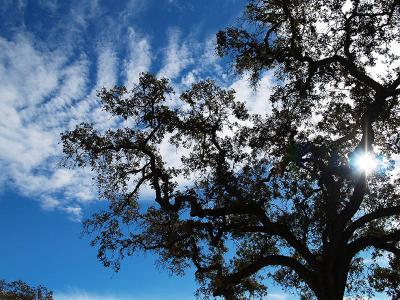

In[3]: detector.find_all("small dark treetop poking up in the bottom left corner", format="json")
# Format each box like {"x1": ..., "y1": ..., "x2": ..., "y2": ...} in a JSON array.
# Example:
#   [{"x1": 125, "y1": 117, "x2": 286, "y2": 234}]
[{"x1": 0, "y1": 280, "x2": 53, "y2": 300}]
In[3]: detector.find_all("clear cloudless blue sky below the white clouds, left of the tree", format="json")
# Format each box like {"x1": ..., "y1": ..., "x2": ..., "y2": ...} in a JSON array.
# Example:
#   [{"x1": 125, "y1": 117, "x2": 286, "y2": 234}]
[{"x1": 0, "y1": 191, "x2": 195, "y2": 299}]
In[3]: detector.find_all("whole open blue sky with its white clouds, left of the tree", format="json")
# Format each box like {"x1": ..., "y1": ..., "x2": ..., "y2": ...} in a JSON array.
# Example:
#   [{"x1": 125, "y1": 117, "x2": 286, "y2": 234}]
[{"x1": 0, "y1": 0, "x2": 288, "y2": 300}]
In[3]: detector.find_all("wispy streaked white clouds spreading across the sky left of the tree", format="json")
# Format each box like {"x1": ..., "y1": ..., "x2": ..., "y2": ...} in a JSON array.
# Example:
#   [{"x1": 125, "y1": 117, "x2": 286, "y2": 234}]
[{"x1": 0, "y1": 1, "x2": 276, "y2": 220}]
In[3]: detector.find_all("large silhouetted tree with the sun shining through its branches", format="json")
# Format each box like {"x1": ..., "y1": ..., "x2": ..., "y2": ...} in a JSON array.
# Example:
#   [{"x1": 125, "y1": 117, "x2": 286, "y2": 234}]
[{"x1": 62, "y1": 0, "x2": 400, "y2": 299}]
